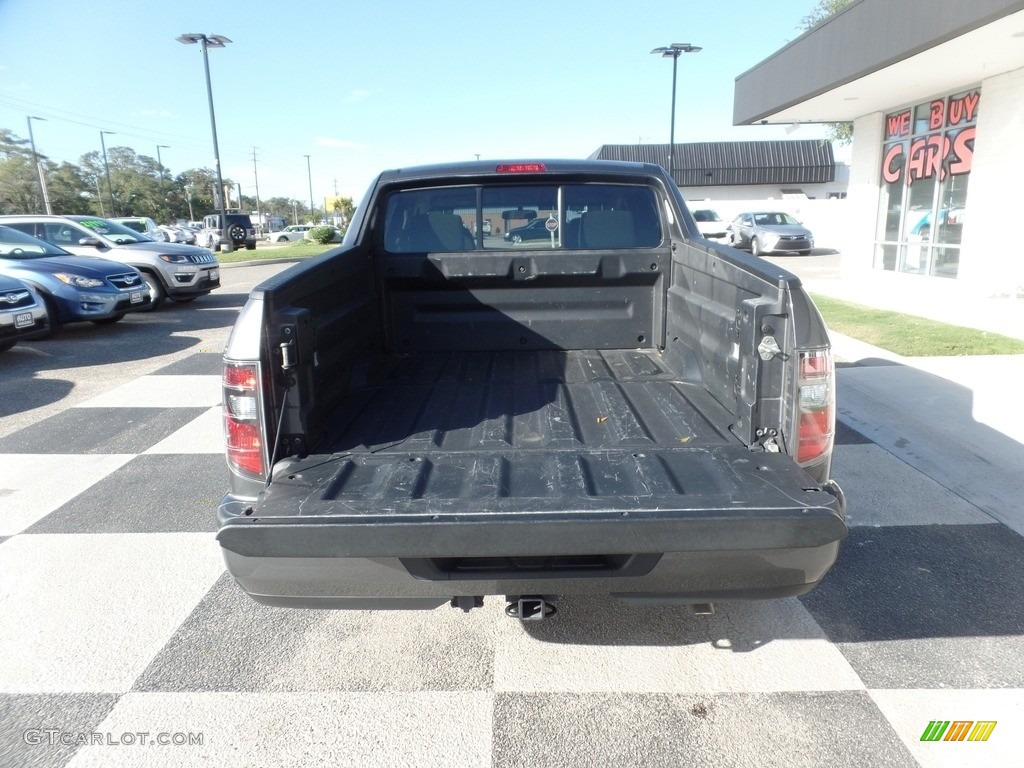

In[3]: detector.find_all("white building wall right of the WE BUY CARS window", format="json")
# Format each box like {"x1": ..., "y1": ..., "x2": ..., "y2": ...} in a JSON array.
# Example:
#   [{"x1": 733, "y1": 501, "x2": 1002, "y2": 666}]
[{"x1": 958, "y1": 69, "x2": 1024, "y2": 296}]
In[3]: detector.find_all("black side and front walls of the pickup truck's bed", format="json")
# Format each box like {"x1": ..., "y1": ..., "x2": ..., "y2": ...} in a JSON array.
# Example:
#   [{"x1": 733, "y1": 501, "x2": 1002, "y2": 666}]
[{"x1": 260, "y1": 242, "x2": 787, "y2": 460}]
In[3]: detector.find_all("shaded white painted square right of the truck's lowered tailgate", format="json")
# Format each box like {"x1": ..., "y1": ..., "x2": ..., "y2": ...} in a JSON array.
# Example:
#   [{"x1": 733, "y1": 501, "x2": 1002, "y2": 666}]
[{"x1": 831, "y1": 444, "x2": 996, "y2": 525}]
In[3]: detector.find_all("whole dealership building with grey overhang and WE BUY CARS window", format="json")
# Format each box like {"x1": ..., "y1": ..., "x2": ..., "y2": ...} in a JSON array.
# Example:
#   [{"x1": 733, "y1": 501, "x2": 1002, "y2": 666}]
[{"x1": 733, "y1": 0, "x2": 1024, "y2": 298}]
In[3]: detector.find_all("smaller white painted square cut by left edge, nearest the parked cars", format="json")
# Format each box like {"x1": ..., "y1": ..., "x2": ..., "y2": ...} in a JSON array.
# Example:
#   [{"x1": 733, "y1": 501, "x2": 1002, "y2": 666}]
[{"x1": 0, "y1": 454, "x2": 135, "y2": 536}]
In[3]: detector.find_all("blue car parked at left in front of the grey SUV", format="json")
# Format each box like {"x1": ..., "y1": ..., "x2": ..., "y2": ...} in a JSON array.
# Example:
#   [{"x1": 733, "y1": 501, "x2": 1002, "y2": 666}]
[{"x1": 0, "y1": 226, "x2": 152, "y2": 332}]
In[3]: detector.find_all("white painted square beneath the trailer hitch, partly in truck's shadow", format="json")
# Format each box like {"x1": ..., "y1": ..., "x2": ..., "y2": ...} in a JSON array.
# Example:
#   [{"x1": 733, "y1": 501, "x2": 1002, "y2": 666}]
[{"x1": 495, "y1": 598, "x2": 864, "y2": 693}]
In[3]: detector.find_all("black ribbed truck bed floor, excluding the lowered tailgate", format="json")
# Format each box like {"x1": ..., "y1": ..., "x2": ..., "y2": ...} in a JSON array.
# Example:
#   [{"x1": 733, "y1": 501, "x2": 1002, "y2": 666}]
[{"x1": 319, "y1": 349, "x2": 733, "y2": 455}]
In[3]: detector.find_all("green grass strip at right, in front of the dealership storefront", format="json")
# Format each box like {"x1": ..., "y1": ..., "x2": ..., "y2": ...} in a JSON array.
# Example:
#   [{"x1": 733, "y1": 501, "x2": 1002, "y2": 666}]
[{"x1": 812, "y1": 295, "x2": 1024, "y2": 357}]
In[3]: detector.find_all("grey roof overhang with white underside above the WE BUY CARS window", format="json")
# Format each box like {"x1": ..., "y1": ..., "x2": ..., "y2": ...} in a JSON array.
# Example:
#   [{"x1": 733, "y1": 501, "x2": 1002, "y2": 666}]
[{"x1": 732, "y1": 0, "x2": 1024, "y2": 125}]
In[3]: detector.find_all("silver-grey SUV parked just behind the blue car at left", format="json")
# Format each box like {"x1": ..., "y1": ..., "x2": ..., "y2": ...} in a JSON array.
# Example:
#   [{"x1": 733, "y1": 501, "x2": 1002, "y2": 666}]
[{"x1": 0, "y1": 214, "x2": 220, "y2": 309}]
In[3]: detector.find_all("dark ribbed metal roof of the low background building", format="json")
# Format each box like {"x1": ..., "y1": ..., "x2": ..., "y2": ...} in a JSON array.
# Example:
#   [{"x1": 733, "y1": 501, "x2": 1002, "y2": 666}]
[{"x1": 590, "y1": 139, "x2": 836, "y2": 186}]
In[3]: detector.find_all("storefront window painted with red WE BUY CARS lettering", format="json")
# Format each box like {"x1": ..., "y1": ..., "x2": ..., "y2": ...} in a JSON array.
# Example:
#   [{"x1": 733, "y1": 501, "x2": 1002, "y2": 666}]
[{"x1": 874, "y1": 90, "x2": 981, "y2": 278}]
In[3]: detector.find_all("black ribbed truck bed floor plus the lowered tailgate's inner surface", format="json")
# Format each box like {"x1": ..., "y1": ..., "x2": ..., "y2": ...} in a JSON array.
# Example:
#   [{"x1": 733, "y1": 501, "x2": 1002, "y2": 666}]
[{"x1": 245, "y1": 350, "x2": 821, "y2": 536}]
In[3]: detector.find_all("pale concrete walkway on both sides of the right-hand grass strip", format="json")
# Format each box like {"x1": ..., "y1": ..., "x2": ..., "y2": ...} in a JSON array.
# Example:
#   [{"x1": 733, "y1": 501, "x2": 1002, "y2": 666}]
[{"x1": 772, "y1": 254, "x2": 1024, "y2": 536}]
